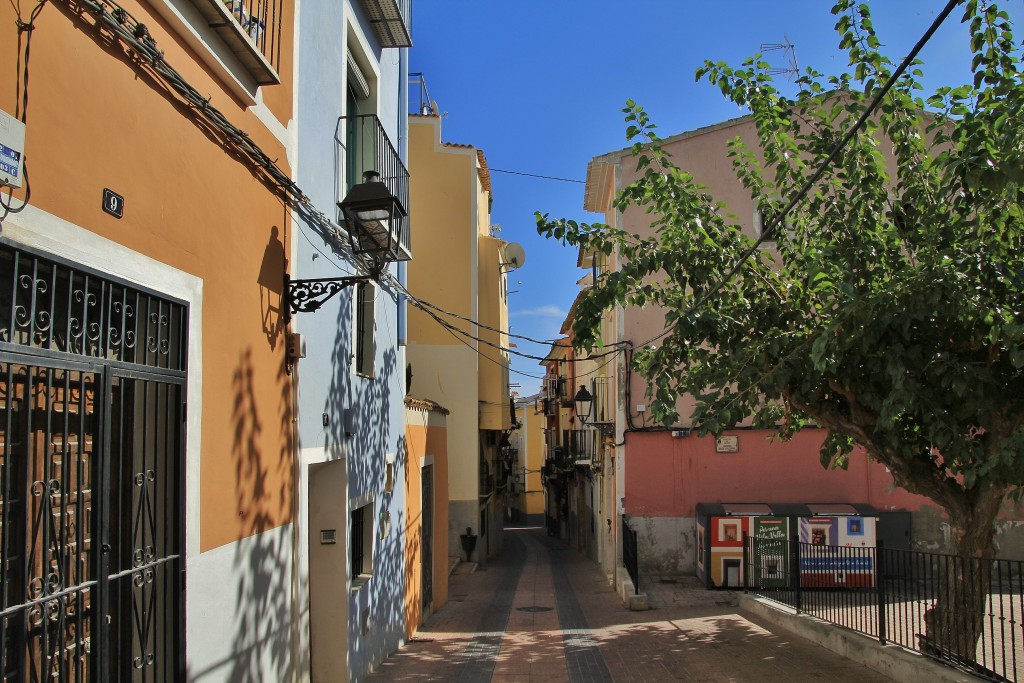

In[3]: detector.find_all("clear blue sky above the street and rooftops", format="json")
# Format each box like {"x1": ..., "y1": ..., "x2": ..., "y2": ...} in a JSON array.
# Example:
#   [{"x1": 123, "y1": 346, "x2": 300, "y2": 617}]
[{"x1": 410, "y1": 0, "x2": 1024, "y2": 395}]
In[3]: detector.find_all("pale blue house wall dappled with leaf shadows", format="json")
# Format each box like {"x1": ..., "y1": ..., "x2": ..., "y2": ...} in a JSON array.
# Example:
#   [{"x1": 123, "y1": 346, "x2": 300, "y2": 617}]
[{"x1": 290, "y1": 2, "x2": 406, "y2": 680}]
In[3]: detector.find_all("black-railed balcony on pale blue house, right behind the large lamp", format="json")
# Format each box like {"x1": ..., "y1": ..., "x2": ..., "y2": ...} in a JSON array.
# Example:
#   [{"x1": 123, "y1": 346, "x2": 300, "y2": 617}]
[{"x1": 337, "y1": 114, "x2": 413, "y2": 261}]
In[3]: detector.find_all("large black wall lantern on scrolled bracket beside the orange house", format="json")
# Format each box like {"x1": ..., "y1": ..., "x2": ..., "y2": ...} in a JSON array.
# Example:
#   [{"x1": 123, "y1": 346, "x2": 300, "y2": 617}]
[{"x1": 284, "y1": 171, "x2": 407, "y2": 321}]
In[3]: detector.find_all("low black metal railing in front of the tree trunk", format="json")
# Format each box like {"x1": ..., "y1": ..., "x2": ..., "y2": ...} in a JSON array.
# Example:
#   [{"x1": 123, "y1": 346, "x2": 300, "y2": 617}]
[{"x1": 743, "y1": 537, "x2": 1024, "y2": 682}]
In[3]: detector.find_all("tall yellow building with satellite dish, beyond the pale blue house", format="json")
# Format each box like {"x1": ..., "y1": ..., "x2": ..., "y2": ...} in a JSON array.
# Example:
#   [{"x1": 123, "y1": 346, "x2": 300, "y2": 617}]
[{"x1": 407, "y1": 115, "x2": 512, "y2": 561}]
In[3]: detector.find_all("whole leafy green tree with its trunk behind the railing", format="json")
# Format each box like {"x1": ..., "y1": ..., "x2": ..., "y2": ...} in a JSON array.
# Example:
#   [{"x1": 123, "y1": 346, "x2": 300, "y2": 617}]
[{"x1": 538, "y1": 0, "x2": 1024, "y2": 660}]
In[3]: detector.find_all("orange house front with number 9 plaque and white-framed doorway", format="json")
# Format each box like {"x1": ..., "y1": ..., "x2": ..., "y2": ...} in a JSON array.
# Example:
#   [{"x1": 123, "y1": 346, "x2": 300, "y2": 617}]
[{"x1": 0, "y1": 0, "x2": 303, "y2": 681}]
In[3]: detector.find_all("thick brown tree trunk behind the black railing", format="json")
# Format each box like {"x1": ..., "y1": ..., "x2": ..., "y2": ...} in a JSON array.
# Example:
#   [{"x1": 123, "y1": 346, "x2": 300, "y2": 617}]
[{"x1": 920, "y1": 490, "x2": 1002, "y2": 665}]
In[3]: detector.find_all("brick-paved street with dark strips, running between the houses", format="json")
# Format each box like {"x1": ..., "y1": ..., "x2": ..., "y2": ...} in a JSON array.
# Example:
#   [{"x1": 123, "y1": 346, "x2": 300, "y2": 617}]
[{"x1": 368, "y1": 528, "x2": 889, "y2": 683}]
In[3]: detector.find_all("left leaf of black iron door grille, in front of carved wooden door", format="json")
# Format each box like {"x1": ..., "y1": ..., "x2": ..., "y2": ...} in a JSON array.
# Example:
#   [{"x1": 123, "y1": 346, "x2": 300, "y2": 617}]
[{"x1": 0, "y1": 364, "x2": 97, "y2": 683}]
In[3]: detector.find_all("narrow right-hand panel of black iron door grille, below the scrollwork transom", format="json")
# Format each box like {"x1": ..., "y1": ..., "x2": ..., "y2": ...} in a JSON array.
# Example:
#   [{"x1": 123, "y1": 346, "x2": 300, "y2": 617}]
[{"x1": 102, "y1": 377, "x2": 182, "y2": 681}]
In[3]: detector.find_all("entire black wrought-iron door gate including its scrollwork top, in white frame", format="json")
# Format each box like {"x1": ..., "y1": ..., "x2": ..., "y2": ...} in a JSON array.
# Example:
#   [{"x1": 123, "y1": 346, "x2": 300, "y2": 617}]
[{"x1": 0, "y1": 239, "x2": 187, "y2": 683}]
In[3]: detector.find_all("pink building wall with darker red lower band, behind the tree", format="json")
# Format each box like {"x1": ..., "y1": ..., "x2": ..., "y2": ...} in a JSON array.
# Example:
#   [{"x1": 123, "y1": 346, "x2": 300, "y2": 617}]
[{"x1": 582, "y1": 117, "x2": 1024, "y2": 575}]
